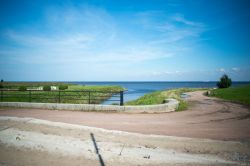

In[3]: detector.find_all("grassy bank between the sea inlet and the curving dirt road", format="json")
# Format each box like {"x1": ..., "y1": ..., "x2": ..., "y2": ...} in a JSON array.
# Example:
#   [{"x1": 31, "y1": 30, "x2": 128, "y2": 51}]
[{"x1": 126, "y1": 88, "x2": 204, "y2": 111}]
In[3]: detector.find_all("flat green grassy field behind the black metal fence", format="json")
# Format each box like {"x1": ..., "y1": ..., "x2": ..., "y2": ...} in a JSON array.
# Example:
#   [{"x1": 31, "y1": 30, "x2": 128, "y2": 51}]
[{"x1": 1, "y1": 82, "x2": 123, "y2": 104}]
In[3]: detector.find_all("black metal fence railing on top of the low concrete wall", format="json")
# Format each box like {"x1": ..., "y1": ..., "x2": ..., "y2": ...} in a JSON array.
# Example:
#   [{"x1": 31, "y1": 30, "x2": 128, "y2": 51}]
[{"x1": 0, "y1": 89, "x2": 124, "y2": 105}]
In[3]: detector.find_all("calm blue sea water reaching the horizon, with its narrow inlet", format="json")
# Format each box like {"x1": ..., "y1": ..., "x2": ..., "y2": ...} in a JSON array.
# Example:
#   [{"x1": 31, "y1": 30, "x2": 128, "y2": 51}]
[{"x1": 74, "y1": 82, "x2": 250, "y2": 104}]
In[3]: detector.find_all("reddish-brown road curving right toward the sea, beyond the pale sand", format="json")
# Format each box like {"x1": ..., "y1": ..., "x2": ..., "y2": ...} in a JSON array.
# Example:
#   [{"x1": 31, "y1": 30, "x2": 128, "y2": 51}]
[{"x1": 0, "y1": 91, "x2": 250, "y2": 140}]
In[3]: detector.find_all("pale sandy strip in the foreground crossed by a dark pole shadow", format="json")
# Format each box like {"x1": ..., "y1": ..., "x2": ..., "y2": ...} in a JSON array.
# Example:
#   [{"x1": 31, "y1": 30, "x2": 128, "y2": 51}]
[{"x1": 0, "y1": 117, "x2": 250, "y2": 166}]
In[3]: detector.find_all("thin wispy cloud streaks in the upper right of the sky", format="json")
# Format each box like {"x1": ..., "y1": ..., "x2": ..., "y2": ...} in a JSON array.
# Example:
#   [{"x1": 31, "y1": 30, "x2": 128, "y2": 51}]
[{"x1": 136, "y1": 11, "x2": 206, "y2": 50}]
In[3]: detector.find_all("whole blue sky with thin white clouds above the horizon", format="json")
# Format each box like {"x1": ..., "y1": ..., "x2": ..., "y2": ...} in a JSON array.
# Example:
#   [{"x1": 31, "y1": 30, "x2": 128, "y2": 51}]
[{"x1": 0, "y1": 0, "x2": 250, "y2": 81}]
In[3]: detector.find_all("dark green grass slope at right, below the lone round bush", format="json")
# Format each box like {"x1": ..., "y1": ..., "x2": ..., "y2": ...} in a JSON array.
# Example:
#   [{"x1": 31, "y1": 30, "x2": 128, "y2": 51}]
[{"x1": 209, "y1": 84, "x2": 250, "y2": 105}]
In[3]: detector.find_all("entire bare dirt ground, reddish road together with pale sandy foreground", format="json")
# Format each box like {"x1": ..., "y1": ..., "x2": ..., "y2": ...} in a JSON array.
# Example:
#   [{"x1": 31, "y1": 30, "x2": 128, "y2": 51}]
[{"x1": 0, "y1": 92, "x2": 250, "y2": 166}]
